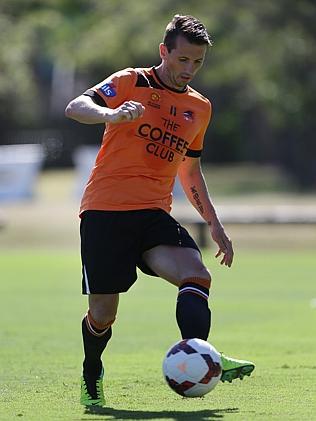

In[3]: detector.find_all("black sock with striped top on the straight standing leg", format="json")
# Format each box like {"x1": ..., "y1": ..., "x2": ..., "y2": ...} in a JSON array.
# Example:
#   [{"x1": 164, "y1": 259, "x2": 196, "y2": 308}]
[{"x1": 82, "y1": 311, "x2": 114, "y2": 377}]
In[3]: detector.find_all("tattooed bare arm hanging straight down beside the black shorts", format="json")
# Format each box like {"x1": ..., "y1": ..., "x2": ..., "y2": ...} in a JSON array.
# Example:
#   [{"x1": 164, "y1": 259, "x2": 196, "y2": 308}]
[{"x1": 178, "y1": 156, "x2": 234, "y2": 267}]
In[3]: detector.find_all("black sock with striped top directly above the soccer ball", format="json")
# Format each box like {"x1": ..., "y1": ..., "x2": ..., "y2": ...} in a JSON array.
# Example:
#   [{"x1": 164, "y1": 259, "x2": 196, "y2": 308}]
[{"x1": 176, "y1": 277, "x2": 211, "y2": 341}]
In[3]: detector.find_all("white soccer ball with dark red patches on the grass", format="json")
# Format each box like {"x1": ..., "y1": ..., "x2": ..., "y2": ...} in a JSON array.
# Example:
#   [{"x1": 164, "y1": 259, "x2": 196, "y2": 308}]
[{"x1": 162, "y1": 338, "x2": 222, "y2": 398}]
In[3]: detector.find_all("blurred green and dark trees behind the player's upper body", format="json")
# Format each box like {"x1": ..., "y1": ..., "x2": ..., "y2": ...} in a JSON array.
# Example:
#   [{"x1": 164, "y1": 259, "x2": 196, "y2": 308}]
[{"x1": 0, "y1": 0, "x2": 316, "y2": 189}]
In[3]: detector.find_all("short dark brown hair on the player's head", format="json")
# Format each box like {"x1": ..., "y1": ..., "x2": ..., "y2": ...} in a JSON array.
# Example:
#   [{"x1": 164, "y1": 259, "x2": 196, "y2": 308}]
[{"x1": 163, "y1": 15, "x2": 213, "y2": 53}]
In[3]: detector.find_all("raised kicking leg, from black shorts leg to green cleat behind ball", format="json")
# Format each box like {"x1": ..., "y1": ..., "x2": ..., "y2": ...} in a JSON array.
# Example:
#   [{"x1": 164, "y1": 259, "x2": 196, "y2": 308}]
[{"x1": 138, "y1": 212, "x2": 254, "y2": 381}]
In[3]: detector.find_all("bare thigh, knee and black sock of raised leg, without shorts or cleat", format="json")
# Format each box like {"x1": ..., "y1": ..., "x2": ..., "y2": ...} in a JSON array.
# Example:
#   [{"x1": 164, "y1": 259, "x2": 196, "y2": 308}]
[{"x1": 143, "y1": 245, "x2": 211, "y2": 340}]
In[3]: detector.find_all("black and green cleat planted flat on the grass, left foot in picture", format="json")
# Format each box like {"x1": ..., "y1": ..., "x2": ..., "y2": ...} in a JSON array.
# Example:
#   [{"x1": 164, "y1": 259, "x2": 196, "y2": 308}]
[{"x1": 80, "y1": 367, "x2": 105, "y2": 406}]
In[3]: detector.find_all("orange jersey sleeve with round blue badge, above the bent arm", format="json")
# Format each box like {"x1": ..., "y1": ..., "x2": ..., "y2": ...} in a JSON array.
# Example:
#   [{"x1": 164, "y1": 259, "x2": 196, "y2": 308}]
[{"x1": 89, "y1": 68, "x2": 137, "y2": 108}]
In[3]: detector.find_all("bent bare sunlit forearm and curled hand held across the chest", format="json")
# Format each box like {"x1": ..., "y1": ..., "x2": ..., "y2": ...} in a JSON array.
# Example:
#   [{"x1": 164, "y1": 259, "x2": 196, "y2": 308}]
[{"x1": 65, "y1": 95, "x2": 145, "y2": 124}]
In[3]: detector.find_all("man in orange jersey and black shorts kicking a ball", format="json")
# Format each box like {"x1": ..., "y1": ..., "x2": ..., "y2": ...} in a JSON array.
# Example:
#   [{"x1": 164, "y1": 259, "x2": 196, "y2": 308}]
[{"x1": 66, "y1": 15, "x2": 254, "y2": 406}]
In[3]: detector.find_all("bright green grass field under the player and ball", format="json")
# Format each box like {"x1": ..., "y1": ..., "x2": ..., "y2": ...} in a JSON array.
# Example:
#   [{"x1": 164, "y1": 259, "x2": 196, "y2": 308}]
[{"x1": 0, "y1": 250, "x2": 316, "y2": 421}]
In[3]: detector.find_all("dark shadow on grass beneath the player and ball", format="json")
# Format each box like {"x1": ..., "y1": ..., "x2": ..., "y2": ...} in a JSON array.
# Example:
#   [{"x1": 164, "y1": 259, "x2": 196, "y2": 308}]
[{"x1": 83, "y1": 407, "x2": 239, "y2": 421}]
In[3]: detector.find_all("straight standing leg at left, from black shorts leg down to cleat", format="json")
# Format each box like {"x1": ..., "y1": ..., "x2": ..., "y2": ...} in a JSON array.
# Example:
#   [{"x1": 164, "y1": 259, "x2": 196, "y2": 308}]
[{"x1": 80, "y1": 211, "x2": 137, "y2": 406}]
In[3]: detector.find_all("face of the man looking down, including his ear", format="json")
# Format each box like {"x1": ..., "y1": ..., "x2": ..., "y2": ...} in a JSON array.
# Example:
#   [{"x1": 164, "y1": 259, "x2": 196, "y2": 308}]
[{"x1": 160, "y1": 36, "x2": 207, "y2": 89}]
